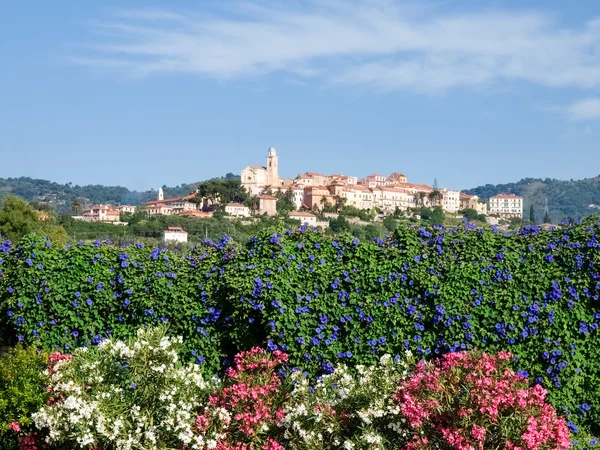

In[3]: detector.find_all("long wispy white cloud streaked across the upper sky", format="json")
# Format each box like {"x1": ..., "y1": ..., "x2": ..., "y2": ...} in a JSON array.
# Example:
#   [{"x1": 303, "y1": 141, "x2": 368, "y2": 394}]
[{"x1": 75, "y1": 0, "x2": 600, "y2": 92}]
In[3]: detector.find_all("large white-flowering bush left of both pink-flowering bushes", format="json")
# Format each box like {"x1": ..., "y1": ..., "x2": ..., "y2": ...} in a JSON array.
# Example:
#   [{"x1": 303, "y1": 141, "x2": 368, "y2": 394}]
[{"x1": 34, "y1": 327, "x2": 215, "y2": 450}]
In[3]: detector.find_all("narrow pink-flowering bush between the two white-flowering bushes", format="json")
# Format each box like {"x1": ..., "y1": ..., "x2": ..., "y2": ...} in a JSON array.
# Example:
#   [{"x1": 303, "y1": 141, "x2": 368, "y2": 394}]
[{"x1": 196, "y1": 348, "x2": 288, "y2": 450}]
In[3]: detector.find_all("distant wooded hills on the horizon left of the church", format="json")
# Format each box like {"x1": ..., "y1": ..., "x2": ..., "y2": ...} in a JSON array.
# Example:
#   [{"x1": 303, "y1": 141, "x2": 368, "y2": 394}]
[{"x1": 0, "y1": 173, "x2": 239, "y2": 213}]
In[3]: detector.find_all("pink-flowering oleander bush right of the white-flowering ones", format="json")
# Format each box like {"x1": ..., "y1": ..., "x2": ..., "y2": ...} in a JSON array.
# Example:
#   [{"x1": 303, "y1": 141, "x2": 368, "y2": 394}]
[{"x1": 394, "y1": 352, "x2": 570, "y2": 450}]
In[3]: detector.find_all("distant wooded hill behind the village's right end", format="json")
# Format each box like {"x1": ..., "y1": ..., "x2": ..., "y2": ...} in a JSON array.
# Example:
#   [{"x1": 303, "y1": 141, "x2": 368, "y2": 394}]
[{"x1": 464, "y1": 175, "x2": 600, "y2": 223}]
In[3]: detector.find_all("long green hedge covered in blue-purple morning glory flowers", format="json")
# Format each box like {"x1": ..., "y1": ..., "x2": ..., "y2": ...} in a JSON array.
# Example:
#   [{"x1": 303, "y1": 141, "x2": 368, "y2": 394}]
[{"x1": 0, "y1": 218, "x2": 600, "y2": 433}]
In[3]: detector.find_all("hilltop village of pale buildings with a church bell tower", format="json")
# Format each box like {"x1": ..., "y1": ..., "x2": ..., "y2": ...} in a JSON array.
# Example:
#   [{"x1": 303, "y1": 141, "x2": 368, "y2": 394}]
[{"x1": 76, "y1": 147, "x2": 523, "y2": 234}]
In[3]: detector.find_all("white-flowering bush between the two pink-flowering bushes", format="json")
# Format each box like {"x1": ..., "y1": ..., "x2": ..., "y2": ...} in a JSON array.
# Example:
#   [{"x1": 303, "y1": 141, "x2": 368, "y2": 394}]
[{"x1": 283, "y1": 355, "x2": 408, "y2": 450}]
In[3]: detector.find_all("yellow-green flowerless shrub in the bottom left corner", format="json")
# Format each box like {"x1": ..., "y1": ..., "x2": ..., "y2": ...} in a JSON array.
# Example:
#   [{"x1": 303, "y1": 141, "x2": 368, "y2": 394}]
[{"x1": 0, "y1": 345, "x2": 48, "y2": 450}]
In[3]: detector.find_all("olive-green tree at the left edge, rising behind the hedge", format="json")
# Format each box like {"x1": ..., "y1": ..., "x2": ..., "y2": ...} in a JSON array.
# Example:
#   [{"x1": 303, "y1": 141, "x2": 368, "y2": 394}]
[{"x1": 0, "y1": 196, "x2": 67, "y2": 245}]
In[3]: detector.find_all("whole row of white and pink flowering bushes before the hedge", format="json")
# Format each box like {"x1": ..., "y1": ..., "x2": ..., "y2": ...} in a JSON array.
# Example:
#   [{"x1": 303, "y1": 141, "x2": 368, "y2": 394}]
[{"x1": 20, "y1": 327, "x2": 589, "y2": 450}]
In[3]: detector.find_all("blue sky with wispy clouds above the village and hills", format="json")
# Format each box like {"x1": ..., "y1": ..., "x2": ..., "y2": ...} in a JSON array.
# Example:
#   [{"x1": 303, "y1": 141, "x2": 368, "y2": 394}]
[{"x1": 0, "y1": 0, "x2": 600, "y2": 189}]
